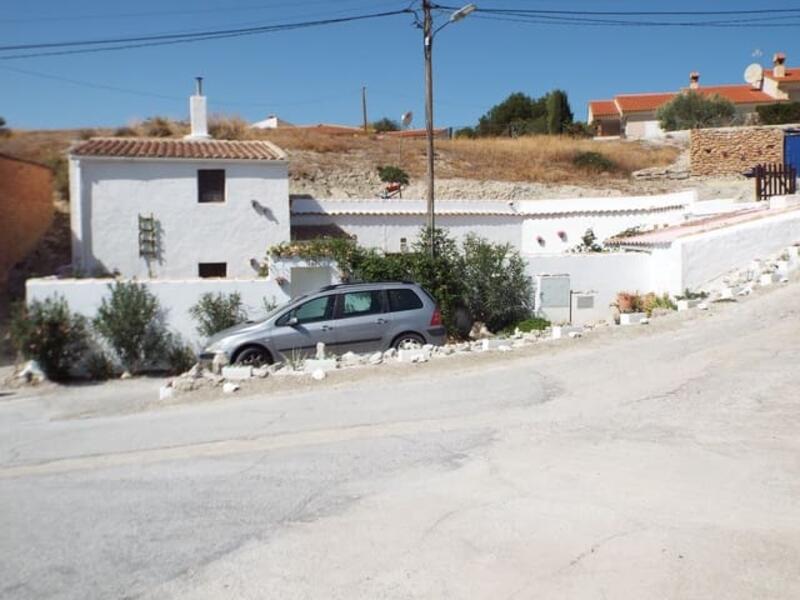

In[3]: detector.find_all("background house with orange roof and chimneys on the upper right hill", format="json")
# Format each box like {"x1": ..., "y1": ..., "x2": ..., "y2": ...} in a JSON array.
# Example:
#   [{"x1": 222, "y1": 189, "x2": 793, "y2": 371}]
[{"x1": 587, "y1": 53, "x2": 800, "y2": 139}]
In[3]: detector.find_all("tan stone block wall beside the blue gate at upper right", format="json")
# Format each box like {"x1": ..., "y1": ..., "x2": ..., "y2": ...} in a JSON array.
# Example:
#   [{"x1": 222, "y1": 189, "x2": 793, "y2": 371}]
[{"x1": 690, "y1": 127, "x2": 783, "y2": 175}]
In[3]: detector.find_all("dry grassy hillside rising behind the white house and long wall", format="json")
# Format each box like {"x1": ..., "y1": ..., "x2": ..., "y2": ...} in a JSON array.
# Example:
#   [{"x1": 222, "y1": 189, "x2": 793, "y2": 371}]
[{"x1": 0, "y1": 117, "x2": 679, "y2": 198}]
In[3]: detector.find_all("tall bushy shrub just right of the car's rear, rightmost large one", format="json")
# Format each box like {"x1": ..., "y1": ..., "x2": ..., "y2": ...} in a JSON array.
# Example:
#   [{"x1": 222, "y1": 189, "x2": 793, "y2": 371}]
[{"x1": 462, "y1": 234, "x2": 533, "y2": 331}]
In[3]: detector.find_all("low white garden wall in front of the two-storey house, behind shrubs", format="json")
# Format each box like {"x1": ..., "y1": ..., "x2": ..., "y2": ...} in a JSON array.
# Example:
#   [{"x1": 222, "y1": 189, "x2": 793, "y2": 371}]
[{"x1": 25, "y1": 279, "x2": 289, "y2": 348}]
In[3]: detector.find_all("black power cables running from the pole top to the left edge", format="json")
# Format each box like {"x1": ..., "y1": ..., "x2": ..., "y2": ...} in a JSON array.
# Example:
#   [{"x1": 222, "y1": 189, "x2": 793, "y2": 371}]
[{"x1": 0, "y1": 9, "x2": 410, "y2": 60}]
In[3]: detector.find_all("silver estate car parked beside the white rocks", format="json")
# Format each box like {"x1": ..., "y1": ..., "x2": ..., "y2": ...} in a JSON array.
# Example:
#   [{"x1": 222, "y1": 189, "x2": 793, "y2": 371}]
[{"x1": 200, "y1": 281, "x2": 445, "y2": 366}]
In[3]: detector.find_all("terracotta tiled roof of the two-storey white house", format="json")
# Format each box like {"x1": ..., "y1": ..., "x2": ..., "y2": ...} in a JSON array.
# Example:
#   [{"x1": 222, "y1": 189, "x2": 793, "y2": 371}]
[{"x1": 70, "y1": 138, "x2": 286, "y2": 160}]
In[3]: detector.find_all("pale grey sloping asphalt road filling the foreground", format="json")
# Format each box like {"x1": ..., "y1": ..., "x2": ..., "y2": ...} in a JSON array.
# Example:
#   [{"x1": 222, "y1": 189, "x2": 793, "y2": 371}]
[{"x1": 0, "y1": 283, "x2": 800, "y2": 600}]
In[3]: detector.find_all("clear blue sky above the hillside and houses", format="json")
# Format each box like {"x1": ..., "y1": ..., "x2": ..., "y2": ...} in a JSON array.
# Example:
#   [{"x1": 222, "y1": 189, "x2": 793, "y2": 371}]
[{"x1": 0, "y1": 0, "x2": 800, "y2": 128}]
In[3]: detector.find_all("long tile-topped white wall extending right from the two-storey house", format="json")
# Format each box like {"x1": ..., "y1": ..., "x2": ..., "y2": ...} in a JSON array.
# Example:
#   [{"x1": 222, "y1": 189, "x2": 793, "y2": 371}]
[{"x1": 292, "y1": 191, "x2": 697, "y2": 254}]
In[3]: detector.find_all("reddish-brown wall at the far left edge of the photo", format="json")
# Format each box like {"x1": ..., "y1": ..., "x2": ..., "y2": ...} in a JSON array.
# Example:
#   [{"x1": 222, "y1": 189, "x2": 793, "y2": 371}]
[{"x1": 0, "y1": 155, "x2": 53, "y2": 292}]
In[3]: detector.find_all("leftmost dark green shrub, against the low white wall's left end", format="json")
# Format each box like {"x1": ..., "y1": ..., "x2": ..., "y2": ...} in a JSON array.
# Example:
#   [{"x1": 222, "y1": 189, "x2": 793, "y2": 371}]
[{"x1": 10, "y1": 297, "x2": 89, "y2": 380}]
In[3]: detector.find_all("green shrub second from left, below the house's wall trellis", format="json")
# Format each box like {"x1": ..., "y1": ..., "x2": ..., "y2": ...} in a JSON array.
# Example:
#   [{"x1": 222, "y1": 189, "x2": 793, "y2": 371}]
[{"x1": 94, "y1": 281, "x2": 169, "y2": 373}]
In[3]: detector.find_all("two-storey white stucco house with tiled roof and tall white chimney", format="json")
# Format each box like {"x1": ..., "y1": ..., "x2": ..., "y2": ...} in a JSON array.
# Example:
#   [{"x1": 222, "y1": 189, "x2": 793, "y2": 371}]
[{"x1": 69, "y1": 89, "x2": 289, "y2": 279}]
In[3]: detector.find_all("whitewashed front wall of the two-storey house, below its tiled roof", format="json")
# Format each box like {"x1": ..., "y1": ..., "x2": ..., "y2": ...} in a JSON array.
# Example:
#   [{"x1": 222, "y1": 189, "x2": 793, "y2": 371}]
[{"x1": 70, "y1": 157, "x2": 289, "y2": 278}]
